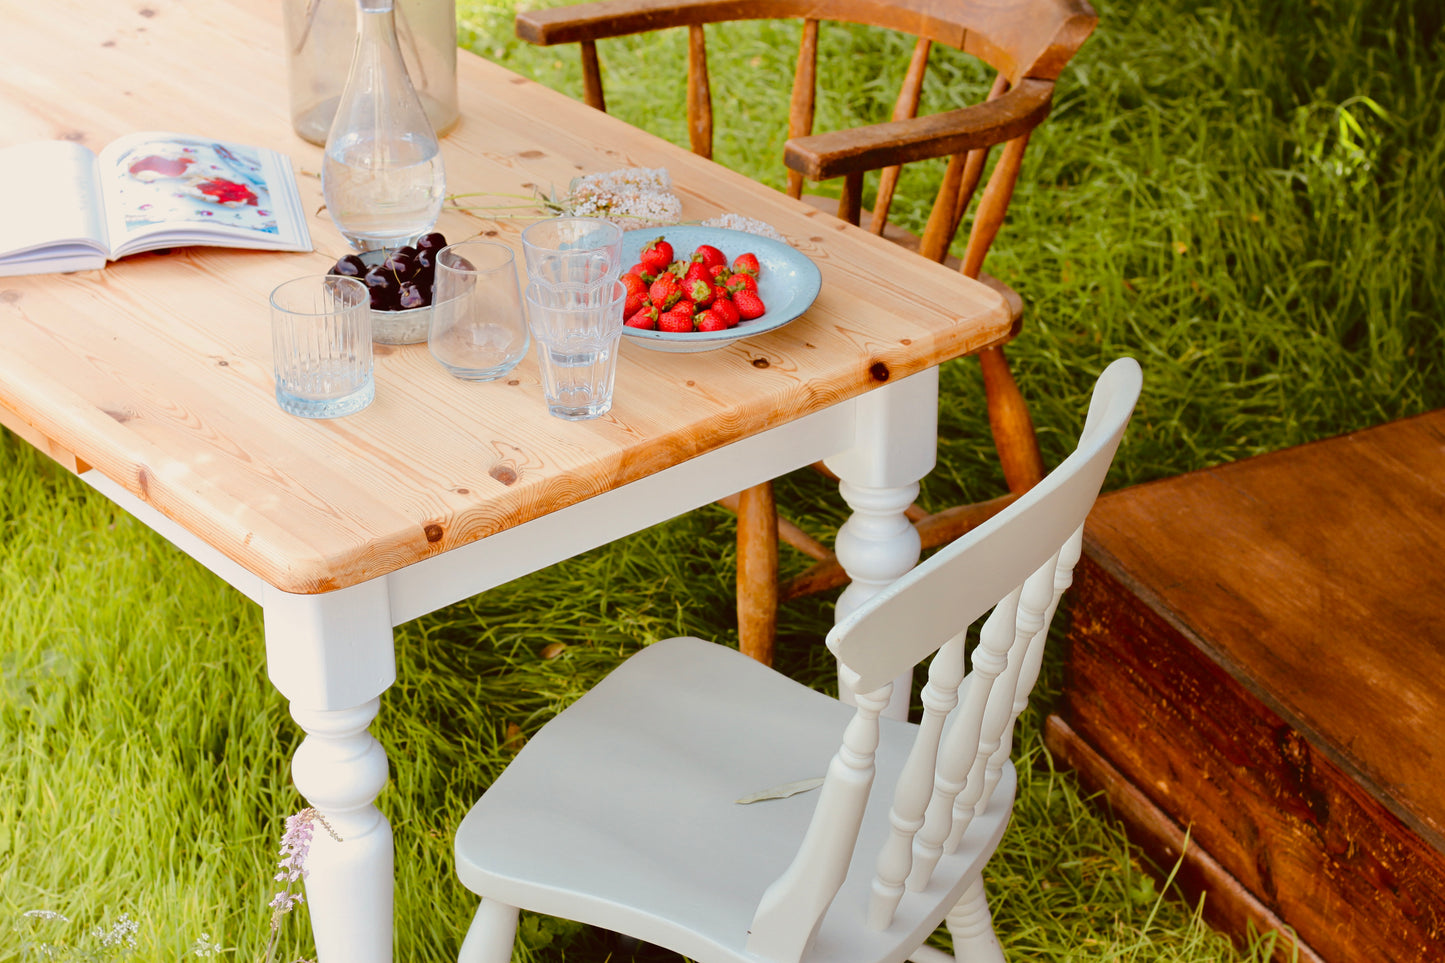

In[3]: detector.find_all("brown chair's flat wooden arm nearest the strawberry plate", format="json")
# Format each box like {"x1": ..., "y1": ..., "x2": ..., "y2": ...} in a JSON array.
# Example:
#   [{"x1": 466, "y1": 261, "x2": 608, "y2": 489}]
[{"x1": 783, "y1": 78, "x2": 1053, "y2": 181}]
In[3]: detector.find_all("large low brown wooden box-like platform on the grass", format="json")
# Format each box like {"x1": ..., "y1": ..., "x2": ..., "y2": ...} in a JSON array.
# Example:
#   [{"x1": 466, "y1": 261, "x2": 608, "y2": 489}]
[{"x1": 1046, "y1": 411, "x2": 1445, "y2": 963}]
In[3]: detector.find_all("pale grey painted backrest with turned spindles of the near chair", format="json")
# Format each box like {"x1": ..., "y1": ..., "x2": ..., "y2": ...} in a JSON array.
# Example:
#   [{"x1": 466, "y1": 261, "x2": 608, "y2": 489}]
[{"x1": 747, "y1": 359, "x2": 1143, "y2": 960}]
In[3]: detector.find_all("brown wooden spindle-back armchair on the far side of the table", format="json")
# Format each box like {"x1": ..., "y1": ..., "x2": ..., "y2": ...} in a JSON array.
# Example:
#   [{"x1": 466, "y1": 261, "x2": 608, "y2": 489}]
[{"x1": 516, "y1": 0, "x2": 1097, "y2": 664}]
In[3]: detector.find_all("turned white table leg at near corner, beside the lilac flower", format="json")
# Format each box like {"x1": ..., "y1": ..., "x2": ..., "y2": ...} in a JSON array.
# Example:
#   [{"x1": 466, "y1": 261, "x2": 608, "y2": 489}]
[{"x1": 264, "y1": 578, "x2": 396, "y2": 963}]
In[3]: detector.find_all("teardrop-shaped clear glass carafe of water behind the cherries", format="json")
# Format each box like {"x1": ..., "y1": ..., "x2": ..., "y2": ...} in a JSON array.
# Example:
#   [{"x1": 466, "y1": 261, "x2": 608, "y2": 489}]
[{"x1": 321, "y1": 0, "x2": 447, "y2": 250}]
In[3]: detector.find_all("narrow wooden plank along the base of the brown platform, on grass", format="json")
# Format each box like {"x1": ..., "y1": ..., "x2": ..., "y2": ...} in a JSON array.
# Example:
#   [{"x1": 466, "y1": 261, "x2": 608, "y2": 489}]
[{"x1": 1043, "y1": 716, "x2": 1324, "y2": 963}]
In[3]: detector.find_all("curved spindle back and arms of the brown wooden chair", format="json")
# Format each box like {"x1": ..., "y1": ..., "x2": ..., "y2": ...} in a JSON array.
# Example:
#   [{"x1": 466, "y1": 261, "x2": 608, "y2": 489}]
[{"x1": 516, "y1": 0, "x2": 1098, "y2": 278}]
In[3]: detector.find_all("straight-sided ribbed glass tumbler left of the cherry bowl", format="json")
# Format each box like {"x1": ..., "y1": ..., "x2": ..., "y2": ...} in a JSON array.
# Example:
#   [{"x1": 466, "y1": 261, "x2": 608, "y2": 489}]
[{"x1": 270, "y1": 275, "x2": 376, "y2": 418}]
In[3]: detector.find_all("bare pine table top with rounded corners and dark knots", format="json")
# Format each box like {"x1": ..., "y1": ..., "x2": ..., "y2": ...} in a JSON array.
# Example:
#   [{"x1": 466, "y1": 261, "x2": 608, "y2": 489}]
[{"x1": 0, "y1": 0, "x2": 1009, "y2": 593}]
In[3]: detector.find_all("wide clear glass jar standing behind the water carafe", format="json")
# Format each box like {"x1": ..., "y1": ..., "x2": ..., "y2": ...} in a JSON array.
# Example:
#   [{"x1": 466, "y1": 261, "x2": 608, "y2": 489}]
[{"x1": 282, "y1": 0, "x2": 460, "y2": 147}]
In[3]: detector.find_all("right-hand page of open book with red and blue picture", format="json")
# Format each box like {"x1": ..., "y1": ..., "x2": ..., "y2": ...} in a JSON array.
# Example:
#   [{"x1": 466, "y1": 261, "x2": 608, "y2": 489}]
[{"x1": 98, "y1": 132, "x2": 311, "y2": 257}]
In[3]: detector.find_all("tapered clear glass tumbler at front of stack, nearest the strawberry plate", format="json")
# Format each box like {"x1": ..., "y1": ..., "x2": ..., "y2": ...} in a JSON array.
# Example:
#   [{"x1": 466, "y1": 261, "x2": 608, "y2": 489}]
[{"x1": 527, "y1": 273, "x2": 627, "y2": 421}]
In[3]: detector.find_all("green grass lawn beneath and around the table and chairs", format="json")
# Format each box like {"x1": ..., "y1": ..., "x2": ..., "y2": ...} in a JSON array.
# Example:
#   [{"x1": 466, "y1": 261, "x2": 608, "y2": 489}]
[{"x1": 0, "y1": 0, "x2": 1445, "y2": 963}]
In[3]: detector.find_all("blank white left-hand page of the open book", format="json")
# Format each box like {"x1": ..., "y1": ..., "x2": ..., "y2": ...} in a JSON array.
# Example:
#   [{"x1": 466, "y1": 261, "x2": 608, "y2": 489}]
[{"x1": 0, "y1": 140, "x2": 108, "y2": 275}]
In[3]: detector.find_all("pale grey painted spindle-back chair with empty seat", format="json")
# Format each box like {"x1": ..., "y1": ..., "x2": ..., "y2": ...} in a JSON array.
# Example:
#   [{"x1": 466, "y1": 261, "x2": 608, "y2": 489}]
[{"x1": 457, "y1": 359, "x2": 1142, "y2": 963}]
